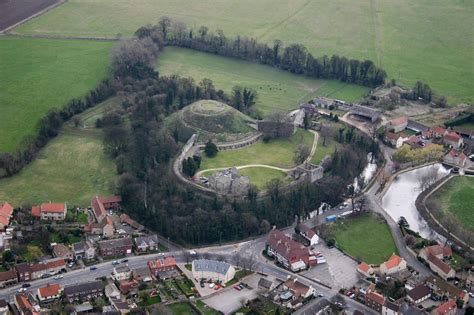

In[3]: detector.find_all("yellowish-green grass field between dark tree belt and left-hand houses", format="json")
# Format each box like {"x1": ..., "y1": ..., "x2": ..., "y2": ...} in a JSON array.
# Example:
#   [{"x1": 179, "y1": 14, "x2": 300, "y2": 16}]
[{"x1": 0, "y1": 99, "x2": 117, "y2": 207}]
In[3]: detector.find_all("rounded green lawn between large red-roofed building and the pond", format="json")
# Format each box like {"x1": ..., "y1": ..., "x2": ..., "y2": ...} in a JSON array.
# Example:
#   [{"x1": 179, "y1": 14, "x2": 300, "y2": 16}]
[{"x1": 332, "y1": 214, "x2": 398, "y2": 264}]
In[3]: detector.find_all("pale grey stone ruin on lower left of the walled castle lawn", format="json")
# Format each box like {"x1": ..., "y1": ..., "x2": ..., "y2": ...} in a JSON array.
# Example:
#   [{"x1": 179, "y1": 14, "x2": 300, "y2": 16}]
[{"x1": 209, "y1": 167, "x2": 250, "y2": 196}]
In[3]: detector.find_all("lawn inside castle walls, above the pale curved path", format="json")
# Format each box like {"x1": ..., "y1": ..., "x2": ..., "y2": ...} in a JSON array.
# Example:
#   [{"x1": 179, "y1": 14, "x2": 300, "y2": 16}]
[{"x1": 201, "y1": 129, "x2": 314, "y2": 170}]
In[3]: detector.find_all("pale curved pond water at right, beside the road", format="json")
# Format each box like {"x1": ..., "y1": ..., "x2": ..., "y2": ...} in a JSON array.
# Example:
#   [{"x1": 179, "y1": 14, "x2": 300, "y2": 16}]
[{"x1": 382, "y1": 163, "x2": 449, "y2": 240}]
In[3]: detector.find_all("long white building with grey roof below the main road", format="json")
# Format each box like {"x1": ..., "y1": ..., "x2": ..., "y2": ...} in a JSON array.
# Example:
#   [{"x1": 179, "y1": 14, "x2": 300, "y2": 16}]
[{"x1": 191, "y1": 259, "x2": 235, "y2": 283}]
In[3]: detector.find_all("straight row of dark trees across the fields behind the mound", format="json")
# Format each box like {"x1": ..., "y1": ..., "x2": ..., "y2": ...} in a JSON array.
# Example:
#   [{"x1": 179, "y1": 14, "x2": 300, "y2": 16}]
[{"x1": 135, "y1": 17, "x2": 387, "y2": 87}]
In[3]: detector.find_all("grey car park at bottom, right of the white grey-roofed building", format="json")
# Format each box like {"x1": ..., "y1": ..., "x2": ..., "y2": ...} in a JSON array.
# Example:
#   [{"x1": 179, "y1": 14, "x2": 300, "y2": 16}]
[{"x1": 202, "y1": 274, "x2": 261, "y2": 314}]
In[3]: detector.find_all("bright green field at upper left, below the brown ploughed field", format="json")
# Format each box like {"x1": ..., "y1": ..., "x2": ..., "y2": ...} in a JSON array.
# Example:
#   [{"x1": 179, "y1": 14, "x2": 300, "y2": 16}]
[{"x1": 0, "y1": 37, "x2": 112, "y2": 152}]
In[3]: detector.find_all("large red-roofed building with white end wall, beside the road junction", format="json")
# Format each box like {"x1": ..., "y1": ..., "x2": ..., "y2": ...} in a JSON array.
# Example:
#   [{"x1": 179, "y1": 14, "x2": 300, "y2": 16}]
[{"x1": 266, "y1": 228, "x2": 317, "y2": 272}]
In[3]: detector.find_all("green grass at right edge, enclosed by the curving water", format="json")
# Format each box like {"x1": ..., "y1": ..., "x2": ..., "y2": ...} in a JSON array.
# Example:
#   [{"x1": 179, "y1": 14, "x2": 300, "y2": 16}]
[{"x1": 430, "y1": 176, "x2": 474, "y2": 232}]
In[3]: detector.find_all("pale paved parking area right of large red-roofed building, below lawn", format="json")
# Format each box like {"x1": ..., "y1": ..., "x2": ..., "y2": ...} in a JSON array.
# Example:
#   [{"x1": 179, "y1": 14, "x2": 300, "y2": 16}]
[{"x1": 302, "y1": 242, "x2": 359, "y2": 288}]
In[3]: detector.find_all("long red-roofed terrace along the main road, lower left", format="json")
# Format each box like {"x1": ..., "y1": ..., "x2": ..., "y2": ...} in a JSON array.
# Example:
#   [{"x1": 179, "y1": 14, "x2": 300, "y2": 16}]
[{"x1": 15, "y1": 258, "x2": 66, "y2": 282}]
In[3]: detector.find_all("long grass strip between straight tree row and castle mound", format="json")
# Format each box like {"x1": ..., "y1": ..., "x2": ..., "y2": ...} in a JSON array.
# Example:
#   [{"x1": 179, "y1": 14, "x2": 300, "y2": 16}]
[{"x1": 157, "y1": 47, "x2": 368, "y2": 114}]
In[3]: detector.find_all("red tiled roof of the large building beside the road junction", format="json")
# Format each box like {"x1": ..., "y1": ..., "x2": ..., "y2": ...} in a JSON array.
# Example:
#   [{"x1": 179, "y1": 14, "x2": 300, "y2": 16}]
[{"x1": 267, "y1": 229, "x2": 309, "y2": 263}]
